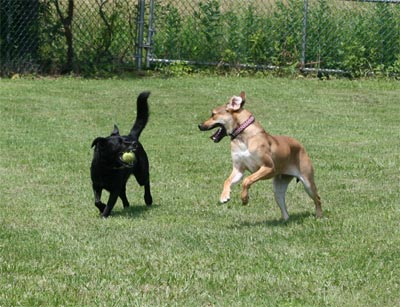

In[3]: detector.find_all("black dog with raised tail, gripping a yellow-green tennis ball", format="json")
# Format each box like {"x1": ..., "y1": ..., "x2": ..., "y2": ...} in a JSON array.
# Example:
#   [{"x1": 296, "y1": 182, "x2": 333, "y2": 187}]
[{"x1": 90, "y1": 92, "x2": 153, "y2": 217}]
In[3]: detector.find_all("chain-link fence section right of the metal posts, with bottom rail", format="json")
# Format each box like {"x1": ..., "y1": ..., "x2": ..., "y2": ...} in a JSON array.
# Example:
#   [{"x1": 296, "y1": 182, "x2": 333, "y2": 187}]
[{"x1": 150, "y1": 0, "x2": 400, "y2": 74}]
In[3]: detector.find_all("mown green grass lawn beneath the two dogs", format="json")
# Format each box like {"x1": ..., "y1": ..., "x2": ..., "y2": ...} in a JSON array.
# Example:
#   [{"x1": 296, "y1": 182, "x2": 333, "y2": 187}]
[{"x1": 0, "y1": 77, "x2": 400, "y2": 307}]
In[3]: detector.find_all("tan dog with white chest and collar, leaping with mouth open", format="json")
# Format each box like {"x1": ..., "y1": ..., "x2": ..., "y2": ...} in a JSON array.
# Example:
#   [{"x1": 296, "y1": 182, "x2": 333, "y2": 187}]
[{"x1": 199, "y1": 92, "x2": 322, "y2": 220}]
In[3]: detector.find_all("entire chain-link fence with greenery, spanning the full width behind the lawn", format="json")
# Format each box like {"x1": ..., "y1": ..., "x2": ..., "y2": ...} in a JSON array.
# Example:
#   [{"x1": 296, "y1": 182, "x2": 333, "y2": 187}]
[{"x1": 0, "y1": 0, "x2": 400, "y2": 75}]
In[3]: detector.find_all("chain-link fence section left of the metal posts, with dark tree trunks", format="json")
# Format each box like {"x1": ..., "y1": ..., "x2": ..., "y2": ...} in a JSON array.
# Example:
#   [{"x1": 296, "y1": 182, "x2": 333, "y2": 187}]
[{"x1": 0, "y1": 0, "x2": 138, "y2": 75}]
